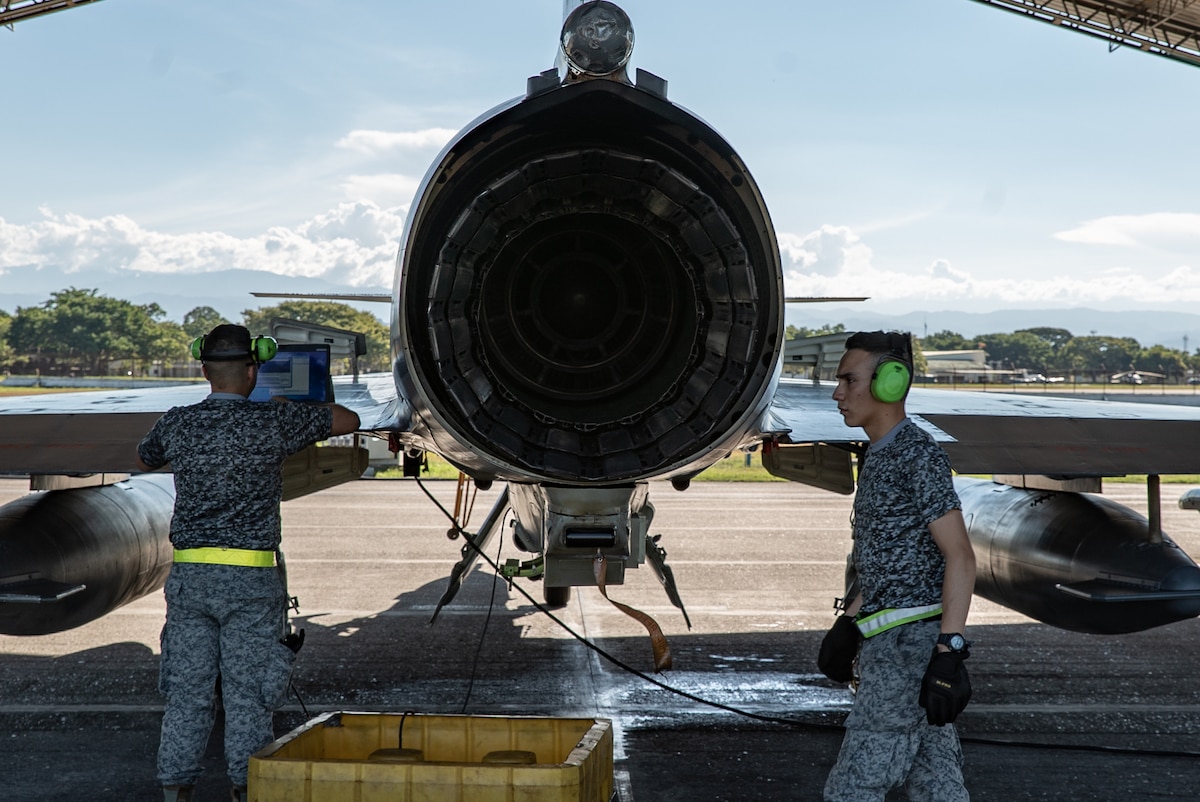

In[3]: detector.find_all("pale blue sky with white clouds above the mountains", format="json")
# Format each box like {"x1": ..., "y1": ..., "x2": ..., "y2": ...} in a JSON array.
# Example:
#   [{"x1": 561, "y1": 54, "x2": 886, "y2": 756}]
[{"x1": 0, "y1": 0, "x2": 1200, "y2": 312}]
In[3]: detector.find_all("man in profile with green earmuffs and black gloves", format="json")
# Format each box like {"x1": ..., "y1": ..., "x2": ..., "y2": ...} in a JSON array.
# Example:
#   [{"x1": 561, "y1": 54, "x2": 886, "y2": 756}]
[{"x1": 824, "y1": 331, "x2": 976, "y2": 802}]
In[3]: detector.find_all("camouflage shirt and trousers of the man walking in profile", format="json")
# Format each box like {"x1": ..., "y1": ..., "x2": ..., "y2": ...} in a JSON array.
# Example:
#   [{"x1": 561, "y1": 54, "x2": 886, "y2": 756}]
[{"x1": 824, "y1": 419, "x2": 970, "y2": 802}]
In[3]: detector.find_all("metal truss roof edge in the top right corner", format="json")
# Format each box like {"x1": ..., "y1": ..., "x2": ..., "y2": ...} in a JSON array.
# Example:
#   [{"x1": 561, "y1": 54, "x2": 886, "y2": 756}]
[{"x1": 976, "y1": 0, "x2": 1200, "y2": 66}]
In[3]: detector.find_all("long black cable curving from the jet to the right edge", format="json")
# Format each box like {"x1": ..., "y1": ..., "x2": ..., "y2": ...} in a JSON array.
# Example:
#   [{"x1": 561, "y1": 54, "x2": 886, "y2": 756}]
[{"x1": 416, "y1": 477, "x2": 1200, "y2": 759}]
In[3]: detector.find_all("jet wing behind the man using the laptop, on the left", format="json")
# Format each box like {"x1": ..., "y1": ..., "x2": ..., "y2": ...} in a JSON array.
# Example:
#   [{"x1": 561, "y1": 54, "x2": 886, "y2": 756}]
[{"x1": 0, "y1": 373, "x2": 408, "y2": 474}]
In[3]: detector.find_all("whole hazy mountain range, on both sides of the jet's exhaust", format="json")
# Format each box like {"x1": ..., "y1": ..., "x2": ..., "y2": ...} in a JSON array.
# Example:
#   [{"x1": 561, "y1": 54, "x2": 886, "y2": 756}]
[{"x1": 0, "y1": 268, "x2": 1200, "y2": 351}]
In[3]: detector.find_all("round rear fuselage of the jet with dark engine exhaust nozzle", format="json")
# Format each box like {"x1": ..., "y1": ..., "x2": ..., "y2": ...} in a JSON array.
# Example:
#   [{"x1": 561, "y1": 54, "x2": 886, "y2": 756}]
[{"x1": 394, "y1": 73, "x2": 782, "y2": 484}]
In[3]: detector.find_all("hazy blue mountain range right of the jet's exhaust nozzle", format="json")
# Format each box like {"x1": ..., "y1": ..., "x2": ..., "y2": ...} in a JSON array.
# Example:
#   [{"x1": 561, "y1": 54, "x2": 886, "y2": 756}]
[{"x1": 787, "y1": 304, "x2": 1200, "y2": 353}]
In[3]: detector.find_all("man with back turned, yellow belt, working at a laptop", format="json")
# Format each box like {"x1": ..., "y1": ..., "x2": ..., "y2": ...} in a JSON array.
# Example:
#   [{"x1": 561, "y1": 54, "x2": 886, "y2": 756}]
[{"x1": 137, "y1": 324, "x2": 359, "y2": 802}]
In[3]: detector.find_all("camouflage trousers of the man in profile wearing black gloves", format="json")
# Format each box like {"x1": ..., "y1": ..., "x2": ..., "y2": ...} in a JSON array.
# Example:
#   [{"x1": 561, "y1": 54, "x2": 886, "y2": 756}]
[{"x1": 824, "y1": 621, "x2": 971, "y2": 802}]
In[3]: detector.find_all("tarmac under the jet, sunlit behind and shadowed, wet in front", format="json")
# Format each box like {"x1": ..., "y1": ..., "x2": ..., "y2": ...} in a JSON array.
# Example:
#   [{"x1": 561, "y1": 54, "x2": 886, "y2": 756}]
[{"x1": 0, "y1": 480, "x2": 1200, "y2": 802}]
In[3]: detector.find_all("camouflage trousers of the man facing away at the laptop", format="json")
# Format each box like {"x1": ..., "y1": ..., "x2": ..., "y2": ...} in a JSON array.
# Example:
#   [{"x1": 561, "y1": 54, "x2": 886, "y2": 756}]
[{"x1": 158, "y1": 563, "x2": 295, "y2": 785}]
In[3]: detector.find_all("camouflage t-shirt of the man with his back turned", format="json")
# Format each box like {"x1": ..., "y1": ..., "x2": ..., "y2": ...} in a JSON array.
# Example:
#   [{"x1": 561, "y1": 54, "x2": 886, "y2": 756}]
[{"x1": 138, "y1": 394, "x2": 334, "y2": 551}]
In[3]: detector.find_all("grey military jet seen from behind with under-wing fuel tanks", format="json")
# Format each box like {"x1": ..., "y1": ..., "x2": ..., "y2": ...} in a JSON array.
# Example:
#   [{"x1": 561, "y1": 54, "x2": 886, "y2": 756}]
[{"x1": 0, "y1": 1, "x2": 1200, "y2": 634}]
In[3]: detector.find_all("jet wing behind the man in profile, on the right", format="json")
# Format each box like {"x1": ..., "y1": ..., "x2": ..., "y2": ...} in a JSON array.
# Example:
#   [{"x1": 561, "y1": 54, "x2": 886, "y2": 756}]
[{"x1": 764, "y1": 379, "x2": 1200, "y2": 477}]
